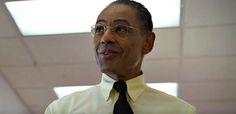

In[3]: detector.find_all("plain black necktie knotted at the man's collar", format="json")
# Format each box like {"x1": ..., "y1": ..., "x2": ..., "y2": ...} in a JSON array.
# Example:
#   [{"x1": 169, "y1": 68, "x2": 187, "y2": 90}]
[{"x1": 113, "y1": 81, "x2": 133, "y2": 114}]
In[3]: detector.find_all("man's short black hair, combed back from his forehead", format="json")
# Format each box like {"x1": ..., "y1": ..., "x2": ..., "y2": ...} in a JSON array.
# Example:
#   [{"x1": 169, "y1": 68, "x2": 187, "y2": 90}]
[{"x1": 108, "y1": 0, "x2": 153, "y2": 32}]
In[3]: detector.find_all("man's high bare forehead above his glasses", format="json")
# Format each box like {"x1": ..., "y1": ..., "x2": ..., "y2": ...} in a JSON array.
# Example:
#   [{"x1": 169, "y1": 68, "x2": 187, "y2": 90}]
[{"x1": 96, "y1": 4, "x2": 138, "y2": 25}]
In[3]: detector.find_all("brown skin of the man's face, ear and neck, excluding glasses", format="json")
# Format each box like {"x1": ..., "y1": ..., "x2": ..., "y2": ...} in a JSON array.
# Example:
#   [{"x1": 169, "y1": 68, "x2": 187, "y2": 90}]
[{"x1": 94, "y1": 4, "x2": 155, "y2": 81}]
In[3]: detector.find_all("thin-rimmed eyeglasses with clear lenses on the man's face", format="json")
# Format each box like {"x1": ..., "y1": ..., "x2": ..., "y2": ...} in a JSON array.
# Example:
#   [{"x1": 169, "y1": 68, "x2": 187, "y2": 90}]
[{"x1": 91, "y1": 24, "x2": 136, "y2": 37}]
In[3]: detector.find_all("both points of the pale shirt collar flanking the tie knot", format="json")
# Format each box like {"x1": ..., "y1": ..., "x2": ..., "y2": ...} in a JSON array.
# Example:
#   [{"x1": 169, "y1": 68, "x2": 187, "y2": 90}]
[{"x1": 100, "y1": 73, "x2": 146, "y2": 102}]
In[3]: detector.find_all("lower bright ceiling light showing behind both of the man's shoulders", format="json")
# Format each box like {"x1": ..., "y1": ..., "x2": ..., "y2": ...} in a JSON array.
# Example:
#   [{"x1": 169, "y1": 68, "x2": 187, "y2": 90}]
[{"x1": 54, "y1": 82, "x2": 178, "y2": 98}]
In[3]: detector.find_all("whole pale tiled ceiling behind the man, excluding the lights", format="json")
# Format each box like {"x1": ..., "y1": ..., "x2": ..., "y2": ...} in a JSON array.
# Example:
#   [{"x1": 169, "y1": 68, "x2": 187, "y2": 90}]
[{"x1": 0, "y1": 0, "x2": 236, "y2": 114}]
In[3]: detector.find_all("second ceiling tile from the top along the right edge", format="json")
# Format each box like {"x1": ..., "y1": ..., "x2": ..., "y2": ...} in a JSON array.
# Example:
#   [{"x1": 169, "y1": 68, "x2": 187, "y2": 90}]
[{"x1": 183, "y1": 25, "x2": 236, "y2": 57}]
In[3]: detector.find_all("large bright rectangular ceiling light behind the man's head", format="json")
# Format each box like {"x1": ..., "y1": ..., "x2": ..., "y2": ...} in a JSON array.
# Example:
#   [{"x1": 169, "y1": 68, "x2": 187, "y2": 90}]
[{"x1": 5, "y1": 0, "x2": 180, "y2": 36}]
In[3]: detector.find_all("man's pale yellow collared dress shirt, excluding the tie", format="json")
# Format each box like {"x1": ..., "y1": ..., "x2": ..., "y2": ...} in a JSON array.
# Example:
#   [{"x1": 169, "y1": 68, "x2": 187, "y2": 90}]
[{"x1": 45, "y1": 74, "x2": 196, "y2": 114}]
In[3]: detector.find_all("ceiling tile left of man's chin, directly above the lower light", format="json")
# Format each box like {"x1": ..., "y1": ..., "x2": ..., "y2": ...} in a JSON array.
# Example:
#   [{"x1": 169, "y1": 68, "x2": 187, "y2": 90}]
[{"x1": 40, "y1": 63, "x2": 101, "y2": 86}]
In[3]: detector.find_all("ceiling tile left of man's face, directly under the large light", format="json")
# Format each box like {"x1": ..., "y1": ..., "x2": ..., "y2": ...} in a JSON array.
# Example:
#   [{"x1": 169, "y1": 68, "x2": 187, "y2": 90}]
[{"x1": 24, "y1": 34, "x2": 95, "y2": 64}]
